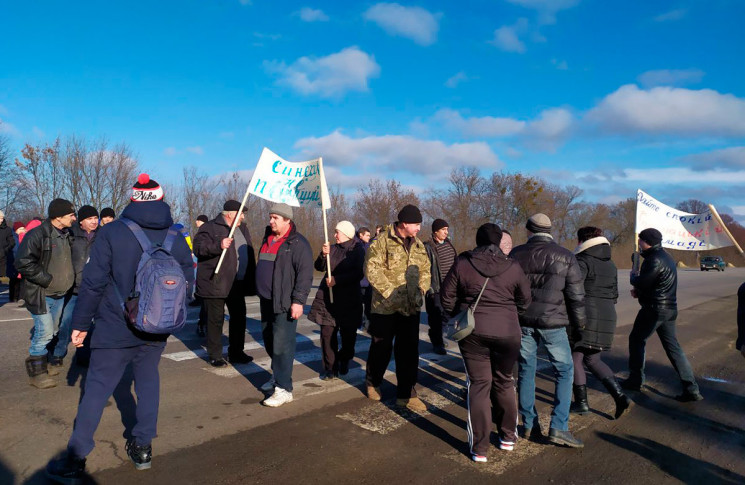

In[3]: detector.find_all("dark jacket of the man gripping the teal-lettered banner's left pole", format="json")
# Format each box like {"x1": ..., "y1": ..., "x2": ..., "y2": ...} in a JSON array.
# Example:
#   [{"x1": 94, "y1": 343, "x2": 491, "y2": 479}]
[{"x1": 193, "y1": 214, "x2": 256, "y2": 298}]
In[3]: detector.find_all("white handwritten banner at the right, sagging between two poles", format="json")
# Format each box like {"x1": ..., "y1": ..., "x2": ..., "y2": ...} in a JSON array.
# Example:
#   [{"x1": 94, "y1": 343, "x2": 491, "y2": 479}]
[{"x1": 636, "y1": 190, "x2": 733, "y2": 251}]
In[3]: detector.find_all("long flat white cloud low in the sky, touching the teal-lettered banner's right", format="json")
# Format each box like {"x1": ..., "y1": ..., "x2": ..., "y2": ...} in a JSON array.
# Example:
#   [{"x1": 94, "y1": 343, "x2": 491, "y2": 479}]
[{"x1": 295, "y1": 130, "x2": 503, "y2": 176}]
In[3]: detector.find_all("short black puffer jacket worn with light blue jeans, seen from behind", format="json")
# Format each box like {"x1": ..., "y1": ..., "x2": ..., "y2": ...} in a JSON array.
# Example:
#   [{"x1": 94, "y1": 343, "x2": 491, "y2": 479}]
[{"x1": 510, "y1": 234, "x2": 585, "y2": 330}]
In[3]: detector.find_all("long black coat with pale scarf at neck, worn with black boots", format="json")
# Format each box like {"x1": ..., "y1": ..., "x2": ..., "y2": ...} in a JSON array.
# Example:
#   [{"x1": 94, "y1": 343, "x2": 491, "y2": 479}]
[{"x1": 570, "y1": 237, "x2": 618, "y2": 350}]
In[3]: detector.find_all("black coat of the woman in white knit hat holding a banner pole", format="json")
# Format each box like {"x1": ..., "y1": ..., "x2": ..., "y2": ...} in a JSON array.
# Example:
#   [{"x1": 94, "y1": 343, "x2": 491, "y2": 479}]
[{"x1": 308, "y1": 239, "x2": 365, "y2": 328}]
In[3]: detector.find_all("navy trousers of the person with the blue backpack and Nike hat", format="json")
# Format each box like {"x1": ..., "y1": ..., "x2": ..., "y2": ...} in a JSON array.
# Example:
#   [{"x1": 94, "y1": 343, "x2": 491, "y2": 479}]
[{"x1": 67, "y1": 345, "x2": 165, "y2": 458}]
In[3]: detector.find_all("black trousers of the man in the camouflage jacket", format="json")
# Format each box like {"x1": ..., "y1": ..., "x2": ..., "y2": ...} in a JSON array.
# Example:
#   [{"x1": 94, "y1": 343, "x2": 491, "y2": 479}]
[{"x1": 366, "y1": 312, "x2": 419, "y2": 399}]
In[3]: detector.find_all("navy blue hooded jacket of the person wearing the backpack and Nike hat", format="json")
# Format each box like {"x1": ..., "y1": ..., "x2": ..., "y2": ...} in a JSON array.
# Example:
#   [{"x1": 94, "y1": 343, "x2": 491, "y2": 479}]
[{"x1": 72, "y1": 201, "x2": 194, "y2": 349}]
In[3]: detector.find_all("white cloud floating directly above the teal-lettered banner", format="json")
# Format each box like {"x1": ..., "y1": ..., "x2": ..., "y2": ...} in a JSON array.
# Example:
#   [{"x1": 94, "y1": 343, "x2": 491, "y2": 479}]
[{"x1": 264, "y1": 47, "x2": 380, "y2": 98}]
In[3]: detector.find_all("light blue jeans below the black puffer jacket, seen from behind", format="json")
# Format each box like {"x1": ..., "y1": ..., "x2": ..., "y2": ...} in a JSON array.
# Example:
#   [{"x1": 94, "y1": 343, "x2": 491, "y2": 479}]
[{"x1": 517, "y1": 327, "x2": 574, "y2": 431}]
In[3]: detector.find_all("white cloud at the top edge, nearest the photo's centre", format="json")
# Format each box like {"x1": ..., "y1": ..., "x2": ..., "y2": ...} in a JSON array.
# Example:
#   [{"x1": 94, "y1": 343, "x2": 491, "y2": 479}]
[{"x1": 363, "y1": 3, "x2": 442, "y2": 46}]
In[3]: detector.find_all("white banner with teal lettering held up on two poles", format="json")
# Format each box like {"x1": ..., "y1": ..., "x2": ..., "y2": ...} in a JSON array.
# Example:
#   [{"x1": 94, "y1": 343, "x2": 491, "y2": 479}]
[{"x1": 249, "y1": 148, "x2": 331, "y2": 209}]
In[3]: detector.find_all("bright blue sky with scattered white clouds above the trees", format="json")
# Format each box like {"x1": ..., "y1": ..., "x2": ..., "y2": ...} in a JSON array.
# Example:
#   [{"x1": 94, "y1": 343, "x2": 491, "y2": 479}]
[{"x1": 0, "y1": 0, "x2": 745, "y2": 216}]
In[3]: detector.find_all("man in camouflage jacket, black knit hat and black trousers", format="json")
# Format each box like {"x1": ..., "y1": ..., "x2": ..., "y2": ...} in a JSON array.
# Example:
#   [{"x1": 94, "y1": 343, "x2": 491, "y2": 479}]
[{"x1": 365, "y1": 205, "x2": 431, "y2": 412}]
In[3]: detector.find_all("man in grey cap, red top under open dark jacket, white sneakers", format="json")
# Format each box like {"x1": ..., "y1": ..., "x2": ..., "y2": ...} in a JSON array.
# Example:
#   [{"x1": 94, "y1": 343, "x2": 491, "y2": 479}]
[{"x1": 256, "y1": 204, "x2": 313, "y2": 407}]
